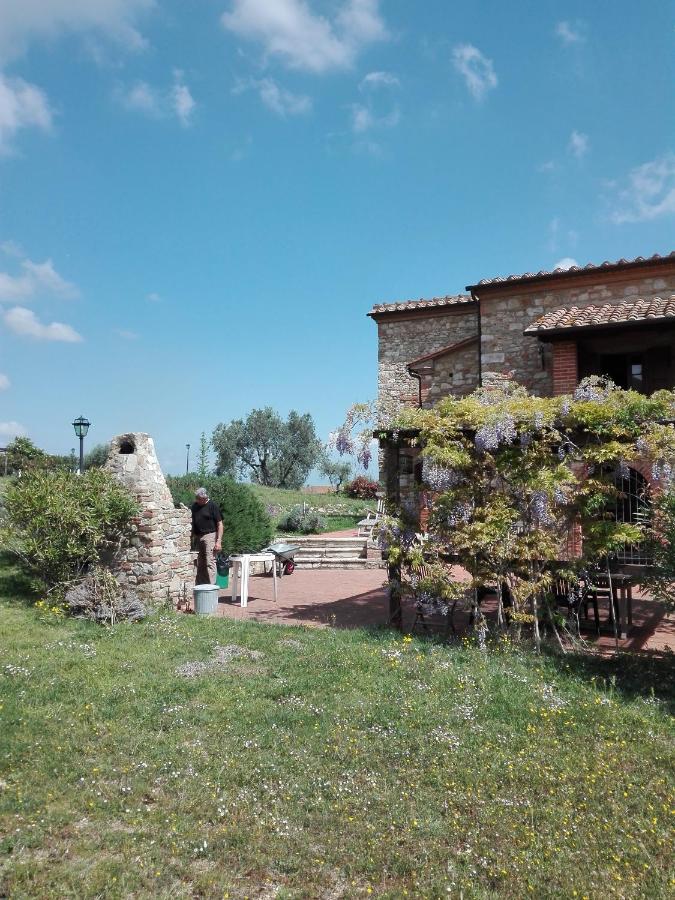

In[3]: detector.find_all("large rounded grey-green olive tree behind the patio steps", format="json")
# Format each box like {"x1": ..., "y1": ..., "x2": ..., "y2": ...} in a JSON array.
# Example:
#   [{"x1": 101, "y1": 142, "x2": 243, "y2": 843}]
[{"x1": 212, "y1": 406, "x2": 323, "y2": 489}]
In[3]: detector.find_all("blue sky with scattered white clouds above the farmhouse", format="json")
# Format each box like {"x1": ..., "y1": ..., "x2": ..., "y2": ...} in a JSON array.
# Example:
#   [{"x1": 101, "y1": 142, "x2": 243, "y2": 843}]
[{"x1": 0, "y1": 0, "x2": 675, "y2": 473}]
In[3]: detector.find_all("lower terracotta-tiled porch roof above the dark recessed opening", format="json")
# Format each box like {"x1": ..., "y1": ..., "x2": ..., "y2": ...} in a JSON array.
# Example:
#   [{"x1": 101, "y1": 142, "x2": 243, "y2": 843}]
[{"x1": 524, "y1": 294, "x2": 675, "y2": 334}]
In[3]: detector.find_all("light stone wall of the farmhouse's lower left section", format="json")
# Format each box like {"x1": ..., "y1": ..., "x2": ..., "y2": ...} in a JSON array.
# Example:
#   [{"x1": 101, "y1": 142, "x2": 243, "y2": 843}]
[{"x1": 377, "y1": 306, "x2": 478, "y2": 412}]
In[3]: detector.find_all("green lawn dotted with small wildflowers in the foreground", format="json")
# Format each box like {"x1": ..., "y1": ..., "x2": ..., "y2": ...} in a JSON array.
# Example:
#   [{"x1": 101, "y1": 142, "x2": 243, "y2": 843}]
[{"x1": 0, "y1": 568, "x2": 673, "y2": 898}]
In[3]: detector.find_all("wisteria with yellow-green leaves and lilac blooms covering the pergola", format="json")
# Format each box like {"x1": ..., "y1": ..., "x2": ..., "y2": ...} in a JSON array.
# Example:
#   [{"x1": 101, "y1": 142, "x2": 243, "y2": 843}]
[{"x1": 385, "y1": 376, "x2": 675, "y2": 644}]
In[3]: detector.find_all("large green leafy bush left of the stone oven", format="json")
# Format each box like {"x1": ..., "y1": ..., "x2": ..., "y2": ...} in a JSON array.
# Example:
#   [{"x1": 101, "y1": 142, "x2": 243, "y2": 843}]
[{"x1": 0, "y1": 469, "x2": 138, "y2": 590}]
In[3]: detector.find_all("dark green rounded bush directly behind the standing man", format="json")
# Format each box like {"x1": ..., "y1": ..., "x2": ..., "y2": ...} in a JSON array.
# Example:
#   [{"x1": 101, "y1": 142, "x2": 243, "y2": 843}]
[{"x1": 167, "y1": 474, "x2": 273, "y2": 554}]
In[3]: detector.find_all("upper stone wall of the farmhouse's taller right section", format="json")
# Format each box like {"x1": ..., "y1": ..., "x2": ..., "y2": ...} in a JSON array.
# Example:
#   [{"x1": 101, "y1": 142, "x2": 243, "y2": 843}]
[{"x1": 478, "y1": 267, "x2": 675, "y2": 396}]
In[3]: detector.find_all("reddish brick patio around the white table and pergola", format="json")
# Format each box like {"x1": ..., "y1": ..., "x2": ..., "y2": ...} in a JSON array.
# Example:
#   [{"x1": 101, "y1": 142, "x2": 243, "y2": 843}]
[{"x1": 197, "y1": 569, "x2": 675, "y2": 653}]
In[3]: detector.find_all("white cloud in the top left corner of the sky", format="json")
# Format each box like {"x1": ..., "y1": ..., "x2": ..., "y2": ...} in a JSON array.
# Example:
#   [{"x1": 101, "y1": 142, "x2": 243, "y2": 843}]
[{"x1": 0, "y1": 0, "x2": 155, "y2": 60}]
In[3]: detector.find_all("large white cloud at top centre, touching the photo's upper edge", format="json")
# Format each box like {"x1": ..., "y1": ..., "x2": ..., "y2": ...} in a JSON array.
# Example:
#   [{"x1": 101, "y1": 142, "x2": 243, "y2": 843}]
[{"x1": 221, "y1": 0, "x2": 388, "y2": 72}]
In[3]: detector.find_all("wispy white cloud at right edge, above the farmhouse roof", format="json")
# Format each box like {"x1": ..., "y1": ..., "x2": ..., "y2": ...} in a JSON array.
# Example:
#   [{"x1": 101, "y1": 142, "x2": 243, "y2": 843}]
[{"x1": 610, "y1": 153, "x2": 675, "y2": 225}]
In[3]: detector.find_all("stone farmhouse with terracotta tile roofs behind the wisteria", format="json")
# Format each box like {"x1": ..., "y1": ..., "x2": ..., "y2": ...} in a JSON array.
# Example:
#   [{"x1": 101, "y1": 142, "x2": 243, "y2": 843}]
[{"x1": 368, "y1": 252, "x2": 675, "y2": 564}]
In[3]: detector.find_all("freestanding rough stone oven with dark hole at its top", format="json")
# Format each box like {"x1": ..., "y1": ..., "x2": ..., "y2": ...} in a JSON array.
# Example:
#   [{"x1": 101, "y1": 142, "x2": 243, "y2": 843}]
[{"x1": 105, "y1": 432, "x2": 194, "y2": 606}]
